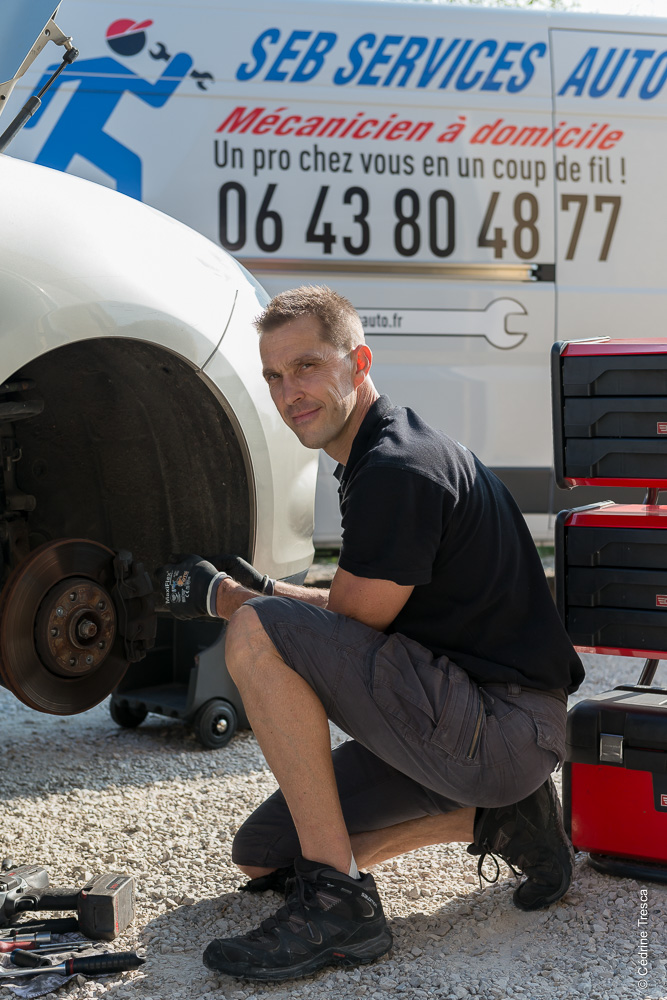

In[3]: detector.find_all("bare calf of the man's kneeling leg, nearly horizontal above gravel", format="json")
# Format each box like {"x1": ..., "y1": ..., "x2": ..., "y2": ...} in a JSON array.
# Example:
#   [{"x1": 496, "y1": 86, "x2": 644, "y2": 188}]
[{"x1": 239, "y1": 806, "x2": 475, "y2": 878}]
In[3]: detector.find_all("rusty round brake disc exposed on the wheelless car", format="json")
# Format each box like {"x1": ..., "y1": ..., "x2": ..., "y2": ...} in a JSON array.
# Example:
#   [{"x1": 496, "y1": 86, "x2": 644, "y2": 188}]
[{"x1": 0, "y1": 538, "x2": 128, "y2": 715}]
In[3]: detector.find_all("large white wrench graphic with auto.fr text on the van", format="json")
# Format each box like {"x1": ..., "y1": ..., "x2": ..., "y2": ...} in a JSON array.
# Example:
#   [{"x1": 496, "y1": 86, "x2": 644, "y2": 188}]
[{"x1": 357, "y1": 299, "x2": 528, "y2": 351}]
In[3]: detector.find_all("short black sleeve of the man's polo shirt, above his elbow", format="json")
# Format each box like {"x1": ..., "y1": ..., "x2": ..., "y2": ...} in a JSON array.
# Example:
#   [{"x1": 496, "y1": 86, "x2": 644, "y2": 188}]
[{"x1": 338, "y1": 465, "x2": 453, "y2": 586}]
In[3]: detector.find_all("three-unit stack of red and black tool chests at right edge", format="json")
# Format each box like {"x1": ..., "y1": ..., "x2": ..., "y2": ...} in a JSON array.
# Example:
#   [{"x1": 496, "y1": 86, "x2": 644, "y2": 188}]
[{"x1": 552, "y1": 338, "x2": 667, "y2": 882}]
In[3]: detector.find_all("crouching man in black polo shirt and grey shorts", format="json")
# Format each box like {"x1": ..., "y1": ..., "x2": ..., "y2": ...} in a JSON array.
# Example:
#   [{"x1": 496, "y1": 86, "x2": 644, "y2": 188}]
[{"x1": 160, "y1": 287, "x2": 583, "y2": 980}]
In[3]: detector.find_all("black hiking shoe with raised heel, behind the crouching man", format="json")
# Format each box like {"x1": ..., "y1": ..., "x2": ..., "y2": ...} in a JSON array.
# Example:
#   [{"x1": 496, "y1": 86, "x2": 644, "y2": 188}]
[{"x1": 468, "y1": 778, "x2": 574, "y2": 910}]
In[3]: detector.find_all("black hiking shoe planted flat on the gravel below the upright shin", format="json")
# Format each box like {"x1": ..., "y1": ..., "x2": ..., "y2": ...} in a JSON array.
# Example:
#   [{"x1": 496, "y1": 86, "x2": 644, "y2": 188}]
[{"x1": 204, "y1": 858, "x2": 392, "y2": 982}]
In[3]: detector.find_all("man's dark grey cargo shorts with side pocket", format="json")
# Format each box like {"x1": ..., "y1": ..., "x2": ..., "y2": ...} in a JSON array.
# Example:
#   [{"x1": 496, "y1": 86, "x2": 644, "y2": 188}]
[{"x1": 232, "y1": 597, "x2": 567, "y2": 868}]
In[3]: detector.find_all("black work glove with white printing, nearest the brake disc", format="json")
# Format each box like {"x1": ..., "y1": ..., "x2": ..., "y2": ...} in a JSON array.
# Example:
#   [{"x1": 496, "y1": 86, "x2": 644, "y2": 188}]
[{"x1": 153, "y1": 556, "x2": 229, "y2": 621}]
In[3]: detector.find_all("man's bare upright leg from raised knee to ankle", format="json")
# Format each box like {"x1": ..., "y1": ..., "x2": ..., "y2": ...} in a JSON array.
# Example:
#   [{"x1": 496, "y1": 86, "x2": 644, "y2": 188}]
[{"x1": 225, "y1": 607, "x2": 352, "y2": 874}]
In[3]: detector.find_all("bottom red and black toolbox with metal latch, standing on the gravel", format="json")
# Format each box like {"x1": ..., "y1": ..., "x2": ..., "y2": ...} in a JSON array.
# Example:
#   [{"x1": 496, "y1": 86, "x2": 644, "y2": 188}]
[{"x1": 563, "y1": 685, "x2": 667, "y2": 862}]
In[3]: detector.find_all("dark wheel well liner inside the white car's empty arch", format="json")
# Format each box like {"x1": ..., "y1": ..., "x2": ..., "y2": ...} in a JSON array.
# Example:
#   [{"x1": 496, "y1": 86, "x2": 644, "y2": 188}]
[{"x1": 15, "y1": 338, "x2": 254, "y2": 570}]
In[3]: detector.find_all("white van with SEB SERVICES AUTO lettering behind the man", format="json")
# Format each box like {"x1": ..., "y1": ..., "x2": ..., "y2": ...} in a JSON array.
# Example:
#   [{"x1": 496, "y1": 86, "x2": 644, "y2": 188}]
[{"x1": 12, "y1": 0, "x2": 667, "y2": 544}]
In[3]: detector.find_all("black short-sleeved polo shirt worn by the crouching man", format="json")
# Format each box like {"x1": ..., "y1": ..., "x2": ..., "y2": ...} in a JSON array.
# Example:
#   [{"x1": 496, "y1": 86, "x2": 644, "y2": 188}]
[{"x1": 335, "y1": 396, "x2": 584, "y2": 692}]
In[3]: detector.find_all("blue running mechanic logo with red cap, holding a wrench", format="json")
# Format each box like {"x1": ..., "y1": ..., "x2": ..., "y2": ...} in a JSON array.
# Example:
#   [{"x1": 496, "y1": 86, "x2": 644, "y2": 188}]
[{"x1": 25, "y1": 19, "x2": 198, "y2": 201}]
